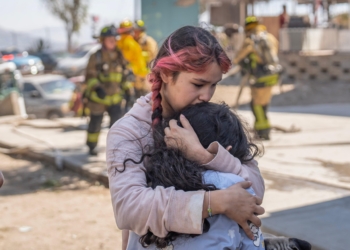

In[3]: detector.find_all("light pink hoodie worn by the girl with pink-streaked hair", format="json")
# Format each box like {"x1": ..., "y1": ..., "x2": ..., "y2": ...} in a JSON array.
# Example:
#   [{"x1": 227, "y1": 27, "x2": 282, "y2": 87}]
[{"x1": 107, "y1": 94, "x2": 265, "y2": 237}]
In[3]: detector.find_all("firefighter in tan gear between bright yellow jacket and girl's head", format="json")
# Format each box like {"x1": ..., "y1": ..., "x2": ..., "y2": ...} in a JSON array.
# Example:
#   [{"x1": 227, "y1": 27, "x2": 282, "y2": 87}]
[{"x1": 134, "y1": 20, "x2": 158, "y2": 98}]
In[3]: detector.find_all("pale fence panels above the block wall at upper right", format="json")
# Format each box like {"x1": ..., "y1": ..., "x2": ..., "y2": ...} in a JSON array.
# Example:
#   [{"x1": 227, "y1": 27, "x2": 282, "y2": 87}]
[{"x1": 280, "y1": 28, "x2": 350, "y2": 52}]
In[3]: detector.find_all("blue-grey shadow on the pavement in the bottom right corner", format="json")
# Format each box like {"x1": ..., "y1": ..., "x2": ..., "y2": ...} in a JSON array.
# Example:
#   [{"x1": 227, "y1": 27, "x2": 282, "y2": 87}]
[{"x1": 262, "y1": 196, "x2": 350, "y2": 250}]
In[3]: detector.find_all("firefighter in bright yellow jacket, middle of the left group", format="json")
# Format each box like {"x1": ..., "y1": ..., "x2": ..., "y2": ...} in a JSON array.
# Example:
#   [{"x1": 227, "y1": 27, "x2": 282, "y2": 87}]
[{"x1": 117, "y1": 20, "x2": 148, "y2": 97}]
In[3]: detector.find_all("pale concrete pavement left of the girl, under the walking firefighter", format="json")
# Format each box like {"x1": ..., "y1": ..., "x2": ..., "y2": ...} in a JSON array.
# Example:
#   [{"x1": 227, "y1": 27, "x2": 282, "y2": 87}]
[{"x1": 0, "y1": 118, "x2": 108, "y2": 187}]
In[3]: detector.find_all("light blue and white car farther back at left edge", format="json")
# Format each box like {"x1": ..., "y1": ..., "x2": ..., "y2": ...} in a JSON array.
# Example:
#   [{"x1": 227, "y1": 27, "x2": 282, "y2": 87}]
[{"x1": 0, "y1": 50, "x2": 45, "y2": 75}]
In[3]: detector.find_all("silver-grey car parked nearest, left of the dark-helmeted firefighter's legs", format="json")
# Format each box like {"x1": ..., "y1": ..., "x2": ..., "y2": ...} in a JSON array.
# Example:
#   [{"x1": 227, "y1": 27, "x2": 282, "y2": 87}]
[{"x1": 21, "y1": 74, "x2": 75, "y2": 119}]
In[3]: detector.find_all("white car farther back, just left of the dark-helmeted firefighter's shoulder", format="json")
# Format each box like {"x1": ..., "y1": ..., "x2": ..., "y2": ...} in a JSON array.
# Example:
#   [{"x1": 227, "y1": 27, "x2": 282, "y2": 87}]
[{"x1": 55, "y1": 43, "x2": 101, "y2": 77}]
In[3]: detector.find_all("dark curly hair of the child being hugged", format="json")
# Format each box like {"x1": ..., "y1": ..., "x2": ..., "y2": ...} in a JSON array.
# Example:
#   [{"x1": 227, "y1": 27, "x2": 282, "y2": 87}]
[{"x1": 124, "y1": 103, "x2": 260, "y2": 248}]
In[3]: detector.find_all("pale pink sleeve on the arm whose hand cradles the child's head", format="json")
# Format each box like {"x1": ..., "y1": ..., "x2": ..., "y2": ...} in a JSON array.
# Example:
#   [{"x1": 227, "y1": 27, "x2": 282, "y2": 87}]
[{"x1": 204, "y1": 142, "x2": 265, "y2": 199}]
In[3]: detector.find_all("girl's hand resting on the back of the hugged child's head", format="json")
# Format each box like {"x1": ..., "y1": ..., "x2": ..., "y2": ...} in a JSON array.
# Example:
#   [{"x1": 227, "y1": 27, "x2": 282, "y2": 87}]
[{"x1": 164, "y1": 115, "x2": 215, "y2": 164}]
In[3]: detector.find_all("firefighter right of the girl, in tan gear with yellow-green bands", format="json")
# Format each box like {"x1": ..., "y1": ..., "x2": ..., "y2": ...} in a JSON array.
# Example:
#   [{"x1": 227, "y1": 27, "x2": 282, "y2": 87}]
[{"x1": 233, "y1": 16, "x2": 281, "y2": 140}]
